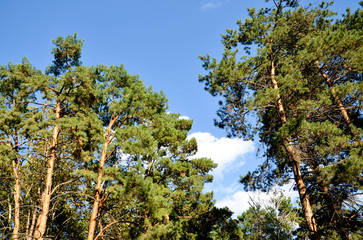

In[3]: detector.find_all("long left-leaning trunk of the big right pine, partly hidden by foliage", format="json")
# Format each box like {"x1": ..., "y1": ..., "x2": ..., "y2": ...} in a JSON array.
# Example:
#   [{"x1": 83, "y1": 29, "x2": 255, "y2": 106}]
[{"x1": 271, "y1": 59, "x2": 321, "y2": 240}]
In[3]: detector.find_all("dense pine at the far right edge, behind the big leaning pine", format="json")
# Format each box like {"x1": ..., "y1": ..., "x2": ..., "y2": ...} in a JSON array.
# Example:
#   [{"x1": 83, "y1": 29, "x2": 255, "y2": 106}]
[{"x1": 290, "y1": 3, "x2": 363, "y2": 239}]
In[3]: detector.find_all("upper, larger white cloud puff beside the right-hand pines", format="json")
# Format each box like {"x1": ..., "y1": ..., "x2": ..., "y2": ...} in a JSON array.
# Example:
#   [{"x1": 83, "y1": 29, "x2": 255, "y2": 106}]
[{"x1": 188, "y1": 132, "x2": 255, "y2": 179}]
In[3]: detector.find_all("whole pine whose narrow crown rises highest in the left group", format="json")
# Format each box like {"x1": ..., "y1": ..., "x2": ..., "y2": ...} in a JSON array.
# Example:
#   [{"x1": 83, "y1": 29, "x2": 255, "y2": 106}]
[{"x1": 29, "y1": 34, "x2": 100, "y2": 239}]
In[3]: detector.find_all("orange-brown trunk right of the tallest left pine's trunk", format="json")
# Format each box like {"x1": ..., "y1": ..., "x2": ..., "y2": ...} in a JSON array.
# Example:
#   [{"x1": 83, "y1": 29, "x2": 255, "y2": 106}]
[{"x1": 87, "y1": 116, "x2": 117, "y2": 240}]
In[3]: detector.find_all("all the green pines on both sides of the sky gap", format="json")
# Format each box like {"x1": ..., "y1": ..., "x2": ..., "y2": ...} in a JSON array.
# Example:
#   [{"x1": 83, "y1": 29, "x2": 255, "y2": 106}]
[{"x1": 0, "y1": 0, "x2": 363, "y2": 240}]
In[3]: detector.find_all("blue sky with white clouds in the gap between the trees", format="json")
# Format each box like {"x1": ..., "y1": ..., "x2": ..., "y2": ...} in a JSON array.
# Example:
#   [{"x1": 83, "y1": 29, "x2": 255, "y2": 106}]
[{"x1": 0, "y1": 0, "x2": 359, "y2": 218}]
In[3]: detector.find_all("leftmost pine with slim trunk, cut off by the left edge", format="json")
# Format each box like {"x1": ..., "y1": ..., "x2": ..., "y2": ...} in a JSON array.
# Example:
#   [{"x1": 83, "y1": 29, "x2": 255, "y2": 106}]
[{"x1": 0, "y1": 58, "x2": 39, "y2": 239}]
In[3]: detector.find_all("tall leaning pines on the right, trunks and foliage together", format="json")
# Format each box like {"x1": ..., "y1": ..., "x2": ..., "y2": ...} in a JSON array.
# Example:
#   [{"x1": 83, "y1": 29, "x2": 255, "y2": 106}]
[{"x1": 200, "y1": 0, "x2": 362, "y2": 239}]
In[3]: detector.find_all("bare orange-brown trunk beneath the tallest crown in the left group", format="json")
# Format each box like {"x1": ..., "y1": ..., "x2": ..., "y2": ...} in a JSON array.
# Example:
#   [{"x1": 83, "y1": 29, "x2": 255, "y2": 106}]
[{"x1": 34, "y1": 102, "x2": 61, "y2": 240}]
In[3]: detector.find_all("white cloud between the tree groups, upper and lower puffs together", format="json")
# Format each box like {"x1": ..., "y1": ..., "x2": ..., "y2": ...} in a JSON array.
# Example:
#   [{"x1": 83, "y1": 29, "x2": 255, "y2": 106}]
[{"x1": 188, "y1": 132, "x2": 298, "y2": 218}]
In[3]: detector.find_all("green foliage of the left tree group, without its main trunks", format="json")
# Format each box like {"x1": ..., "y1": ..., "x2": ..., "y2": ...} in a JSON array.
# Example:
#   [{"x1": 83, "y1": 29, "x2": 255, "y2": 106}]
[{"x1": 0, "y1": 34, "x2": 238, "y2": 239}]
